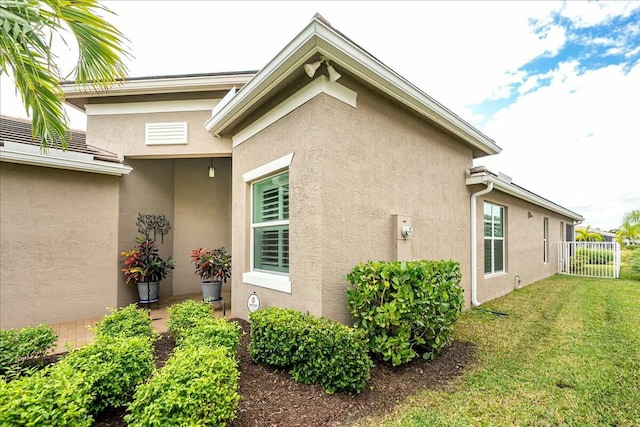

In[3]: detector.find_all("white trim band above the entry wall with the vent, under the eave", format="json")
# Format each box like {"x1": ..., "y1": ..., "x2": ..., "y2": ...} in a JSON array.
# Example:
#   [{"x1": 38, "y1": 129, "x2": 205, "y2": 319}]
[{"x1": 85, "y1": 99, "x2": 220, "y2": 116}]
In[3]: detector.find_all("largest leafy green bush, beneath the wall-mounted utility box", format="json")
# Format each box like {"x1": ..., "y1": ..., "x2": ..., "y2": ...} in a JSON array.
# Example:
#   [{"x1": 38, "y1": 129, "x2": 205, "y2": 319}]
[{"x1": 347, "y1": 261, "x2": 464, "y2": 366}]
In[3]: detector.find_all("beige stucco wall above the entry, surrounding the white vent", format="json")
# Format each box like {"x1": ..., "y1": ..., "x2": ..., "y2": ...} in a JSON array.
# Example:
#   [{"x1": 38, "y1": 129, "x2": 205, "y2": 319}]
[{"x1": 87, "y1": 110, "x2": 231, "y2": 158}]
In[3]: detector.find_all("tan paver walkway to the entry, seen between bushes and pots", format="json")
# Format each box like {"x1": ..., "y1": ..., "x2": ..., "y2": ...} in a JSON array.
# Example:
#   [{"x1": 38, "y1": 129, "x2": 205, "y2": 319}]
[{"x1": 51, "y1": 286, "x2": 232, "y2": 354}]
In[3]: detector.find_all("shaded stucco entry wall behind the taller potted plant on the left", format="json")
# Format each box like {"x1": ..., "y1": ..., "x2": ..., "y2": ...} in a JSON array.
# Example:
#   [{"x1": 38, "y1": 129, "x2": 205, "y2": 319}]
[{"x1": 113, "y1": 159, "x2": 175, "y2": 307}]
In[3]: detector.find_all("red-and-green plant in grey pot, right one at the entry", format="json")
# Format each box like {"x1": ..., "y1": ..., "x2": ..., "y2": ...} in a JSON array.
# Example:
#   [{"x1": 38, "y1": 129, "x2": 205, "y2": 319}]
[{"x1": 189, "y1": 247, "x2": 231, "y2": 301}]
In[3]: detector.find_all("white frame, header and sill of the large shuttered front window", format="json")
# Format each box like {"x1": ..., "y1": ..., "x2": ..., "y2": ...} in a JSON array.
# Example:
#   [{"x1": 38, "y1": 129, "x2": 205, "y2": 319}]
[{"x1": 242, "y1": 153, "x2": 293, "y2": 294}]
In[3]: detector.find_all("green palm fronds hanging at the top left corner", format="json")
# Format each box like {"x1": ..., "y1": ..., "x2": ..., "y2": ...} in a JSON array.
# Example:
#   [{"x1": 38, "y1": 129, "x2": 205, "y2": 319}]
[{"x1": 0, "y1": 0, "x2": 130, "y2": 151}]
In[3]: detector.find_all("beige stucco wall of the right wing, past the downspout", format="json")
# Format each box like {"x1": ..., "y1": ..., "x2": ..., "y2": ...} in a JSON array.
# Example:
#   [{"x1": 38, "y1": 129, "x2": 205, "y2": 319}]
[{"x1": 473, "y1": 186, "x2": 572, "y2": 303}]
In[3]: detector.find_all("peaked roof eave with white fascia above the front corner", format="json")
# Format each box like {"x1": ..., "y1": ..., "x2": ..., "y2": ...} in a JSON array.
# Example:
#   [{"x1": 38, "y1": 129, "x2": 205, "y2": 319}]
[{"x1": 205, "y1": 15, "x2": 501, "y2": 157}]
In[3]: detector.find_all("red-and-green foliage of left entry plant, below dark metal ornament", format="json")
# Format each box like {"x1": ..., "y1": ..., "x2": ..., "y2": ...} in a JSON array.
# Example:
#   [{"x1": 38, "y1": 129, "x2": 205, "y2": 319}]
[{"x1": 120, "y1": 237, "x2": 175, "y2": 286}]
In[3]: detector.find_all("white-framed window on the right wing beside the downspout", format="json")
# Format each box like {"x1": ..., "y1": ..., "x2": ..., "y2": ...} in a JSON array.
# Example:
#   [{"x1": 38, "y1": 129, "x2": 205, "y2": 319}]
[{"x1": 484, "y1": 203, "x2": 504, "y2": 274}]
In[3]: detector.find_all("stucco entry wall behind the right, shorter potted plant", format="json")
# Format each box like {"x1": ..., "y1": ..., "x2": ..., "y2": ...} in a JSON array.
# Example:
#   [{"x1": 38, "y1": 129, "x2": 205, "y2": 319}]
[{"x1": 173, "y1": 158, "x2": 233, "y2": 295}]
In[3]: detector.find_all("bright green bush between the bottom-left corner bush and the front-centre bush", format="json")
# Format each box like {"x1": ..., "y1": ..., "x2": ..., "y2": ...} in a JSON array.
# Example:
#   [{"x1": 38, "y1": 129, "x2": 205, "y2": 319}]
[{"x1": 56, "y1": 337, "x2": 155, "y2": 413}]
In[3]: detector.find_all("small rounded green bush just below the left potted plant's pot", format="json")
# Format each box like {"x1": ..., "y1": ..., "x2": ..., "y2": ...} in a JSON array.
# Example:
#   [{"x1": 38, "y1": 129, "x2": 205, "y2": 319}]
[{"x1": 95, "y1": 304, "x2": 153, "y2": 338}]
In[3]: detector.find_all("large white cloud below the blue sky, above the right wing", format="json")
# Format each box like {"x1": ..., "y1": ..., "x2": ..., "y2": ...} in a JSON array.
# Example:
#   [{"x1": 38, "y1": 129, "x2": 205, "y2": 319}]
[{"x1": 477, "y1": 61, "x2": 640, "y2": 229}]
